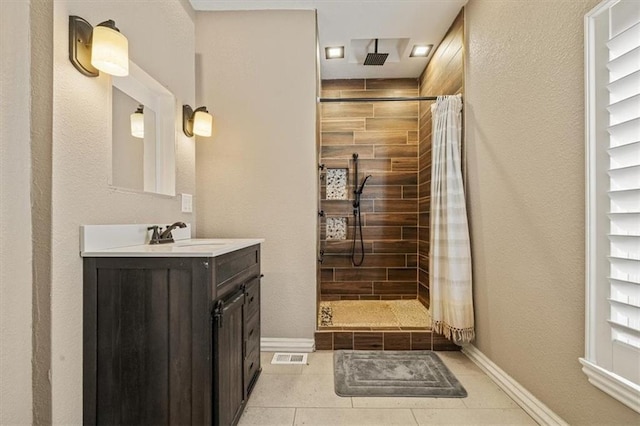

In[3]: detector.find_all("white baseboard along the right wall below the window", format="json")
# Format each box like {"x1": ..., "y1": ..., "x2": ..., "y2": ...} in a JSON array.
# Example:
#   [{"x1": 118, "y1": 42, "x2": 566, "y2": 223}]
[{"x1": 462, "y1": 344, "x2": 568, "y2": 425}]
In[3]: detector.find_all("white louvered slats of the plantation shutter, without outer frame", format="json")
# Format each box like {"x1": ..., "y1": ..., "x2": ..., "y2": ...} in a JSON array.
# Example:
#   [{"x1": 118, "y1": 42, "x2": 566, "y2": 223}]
[{"x1": 607, "y1": 1, "x2": 640, "y2": 384}]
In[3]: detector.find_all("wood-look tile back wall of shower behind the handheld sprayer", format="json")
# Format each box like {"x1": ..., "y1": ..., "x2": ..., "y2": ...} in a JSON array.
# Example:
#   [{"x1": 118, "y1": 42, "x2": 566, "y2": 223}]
[{"x1": 318, "y1": 79, "x2": 419, "y2": 300}]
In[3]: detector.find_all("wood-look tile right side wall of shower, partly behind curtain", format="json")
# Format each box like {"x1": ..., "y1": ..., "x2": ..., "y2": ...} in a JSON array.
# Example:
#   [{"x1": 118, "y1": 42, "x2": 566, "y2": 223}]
[{"x1": 418, "y1": 11, "x2": 464, "y2": 307}]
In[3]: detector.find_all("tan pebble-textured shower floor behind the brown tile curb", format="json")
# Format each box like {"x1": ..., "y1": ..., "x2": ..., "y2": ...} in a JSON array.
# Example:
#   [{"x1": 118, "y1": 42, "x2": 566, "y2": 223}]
[{"x1": 318, "y1": 300, "x2": 431, "y2": 330}]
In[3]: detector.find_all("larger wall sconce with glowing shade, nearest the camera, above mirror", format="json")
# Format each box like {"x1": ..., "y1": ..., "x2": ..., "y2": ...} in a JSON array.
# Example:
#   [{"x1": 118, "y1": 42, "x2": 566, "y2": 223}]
[{"x1": 69, "y1": 16, "x2": 129, "y2": 77}]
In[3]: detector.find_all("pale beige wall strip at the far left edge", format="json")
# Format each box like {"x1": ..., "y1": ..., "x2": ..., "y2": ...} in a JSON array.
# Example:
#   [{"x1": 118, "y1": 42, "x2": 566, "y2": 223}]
[{"x1": 0, "y1": 1, "x2": 32, "y2": 425}]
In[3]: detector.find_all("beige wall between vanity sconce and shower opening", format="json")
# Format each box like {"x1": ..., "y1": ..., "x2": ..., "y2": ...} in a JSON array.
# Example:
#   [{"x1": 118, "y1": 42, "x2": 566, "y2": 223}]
[{"x1": 196, "y1": 11, "x2": 317, "y2": 339}]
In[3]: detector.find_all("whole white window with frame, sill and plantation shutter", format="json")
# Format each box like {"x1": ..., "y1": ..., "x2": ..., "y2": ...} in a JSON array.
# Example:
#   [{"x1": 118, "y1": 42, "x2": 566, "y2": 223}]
[{"x1": 580, "y1": 0, "x2": 640, "y2": 412}]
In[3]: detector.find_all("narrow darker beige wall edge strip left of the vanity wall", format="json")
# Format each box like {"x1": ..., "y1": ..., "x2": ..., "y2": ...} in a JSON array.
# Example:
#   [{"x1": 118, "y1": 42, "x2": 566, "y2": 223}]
[{"x1": 29, "y1": 0, "x2": 54, "y2": 424}]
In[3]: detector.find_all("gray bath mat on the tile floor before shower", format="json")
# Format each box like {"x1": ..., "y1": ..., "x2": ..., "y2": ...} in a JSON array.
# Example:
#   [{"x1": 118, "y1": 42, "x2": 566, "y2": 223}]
[{"x1": 333, "y1": 351, "x2": 467, "y2": 398}]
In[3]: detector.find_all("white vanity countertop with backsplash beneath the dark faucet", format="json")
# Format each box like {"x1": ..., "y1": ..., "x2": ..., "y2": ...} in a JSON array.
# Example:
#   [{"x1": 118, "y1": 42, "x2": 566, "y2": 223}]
[{"x1": 80, "y1": 224, "x2": 264, "y2": 257}]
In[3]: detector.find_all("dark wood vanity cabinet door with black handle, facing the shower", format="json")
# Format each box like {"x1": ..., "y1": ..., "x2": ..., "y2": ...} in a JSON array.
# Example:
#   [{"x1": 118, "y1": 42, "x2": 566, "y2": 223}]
[{"x1": 213, "y1": 292, "x2": 244, "y2": 426}]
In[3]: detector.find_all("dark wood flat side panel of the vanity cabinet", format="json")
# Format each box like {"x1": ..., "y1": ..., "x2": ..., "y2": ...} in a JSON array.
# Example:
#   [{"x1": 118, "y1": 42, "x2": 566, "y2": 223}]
[{"x1": 83, "y1": 258, "x2": 211, "y2": 425}]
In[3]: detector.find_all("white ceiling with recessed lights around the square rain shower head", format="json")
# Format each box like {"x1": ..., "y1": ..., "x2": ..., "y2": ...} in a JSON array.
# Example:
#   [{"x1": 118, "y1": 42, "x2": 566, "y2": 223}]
[{"x1": 190, "y1": 0, "x2": 467, "y2": 79}]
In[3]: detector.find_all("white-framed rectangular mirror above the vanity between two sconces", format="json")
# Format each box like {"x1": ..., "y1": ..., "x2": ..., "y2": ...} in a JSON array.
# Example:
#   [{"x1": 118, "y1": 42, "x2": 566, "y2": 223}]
[{"x1": 110, "y1": 62, "x2": 176, "y2": 195}]
